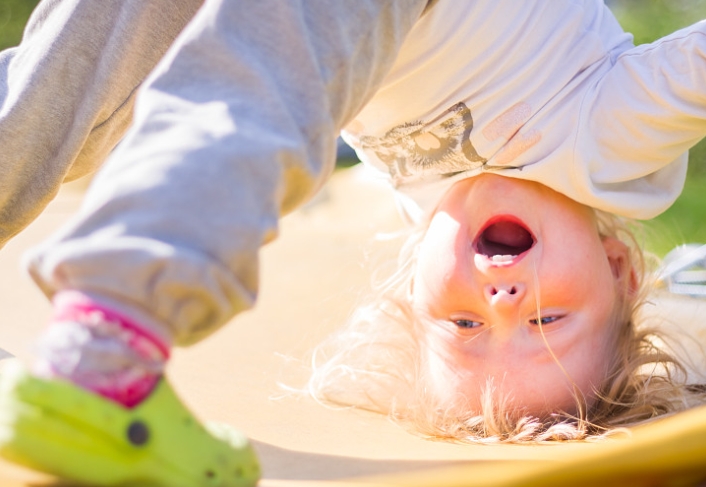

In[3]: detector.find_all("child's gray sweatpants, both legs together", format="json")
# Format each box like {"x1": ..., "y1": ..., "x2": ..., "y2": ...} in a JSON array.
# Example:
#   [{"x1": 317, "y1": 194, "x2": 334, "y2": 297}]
[{"x1": 0, "y1": 0, "x2": 427, "y2": 345}]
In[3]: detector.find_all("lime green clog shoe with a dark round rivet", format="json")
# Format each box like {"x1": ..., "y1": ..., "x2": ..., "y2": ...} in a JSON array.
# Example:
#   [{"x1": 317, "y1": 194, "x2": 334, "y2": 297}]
[{"x1": 0, "y1": 363, "x2": 260, "y2": 487}]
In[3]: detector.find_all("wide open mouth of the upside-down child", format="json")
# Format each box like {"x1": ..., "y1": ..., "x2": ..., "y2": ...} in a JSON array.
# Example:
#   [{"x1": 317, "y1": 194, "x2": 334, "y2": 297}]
[{"x1": 473, "y1": 218, "x2": 535, "y2": 262}]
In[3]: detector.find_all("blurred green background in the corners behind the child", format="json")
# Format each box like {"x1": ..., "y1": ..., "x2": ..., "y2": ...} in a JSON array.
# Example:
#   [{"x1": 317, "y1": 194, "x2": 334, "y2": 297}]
[{"x1": 0, "y1": 0, "x2": 706, "y2": 255}]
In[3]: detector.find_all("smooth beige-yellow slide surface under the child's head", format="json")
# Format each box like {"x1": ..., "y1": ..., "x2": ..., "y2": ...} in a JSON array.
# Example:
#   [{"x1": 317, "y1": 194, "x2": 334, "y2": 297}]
[{"x1": 0, "y1": 167, "x2": 706, "y2": 487}]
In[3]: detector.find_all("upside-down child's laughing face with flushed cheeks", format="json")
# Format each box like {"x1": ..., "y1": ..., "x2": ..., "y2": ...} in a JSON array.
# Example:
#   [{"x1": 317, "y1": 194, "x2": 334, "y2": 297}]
[{"x1": 412, "y1": 175, "x2": 626, "y2": 416}]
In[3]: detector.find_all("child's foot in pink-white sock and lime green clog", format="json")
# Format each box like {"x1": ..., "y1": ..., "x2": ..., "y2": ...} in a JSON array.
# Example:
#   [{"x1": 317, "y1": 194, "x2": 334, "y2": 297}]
[{"x1": 0, "y1": 296, "x2": 259, "y2": 487}]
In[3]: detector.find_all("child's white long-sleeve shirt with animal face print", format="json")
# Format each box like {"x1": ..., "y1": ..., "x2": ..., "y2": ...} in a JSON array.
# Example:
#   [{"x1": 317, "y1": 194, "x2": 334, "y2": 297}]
[{"x1": 344, "y1": 0, "x2": 706, "y2": 220}]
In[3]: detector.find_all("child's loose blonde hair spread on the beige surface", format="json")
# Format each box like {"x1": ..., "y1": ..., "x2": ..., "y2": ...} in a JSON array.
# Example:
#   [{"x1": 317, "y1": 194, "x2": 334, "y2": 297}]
[{"x1": 307, "y1": 212, "x2": 706, "y2": 443}]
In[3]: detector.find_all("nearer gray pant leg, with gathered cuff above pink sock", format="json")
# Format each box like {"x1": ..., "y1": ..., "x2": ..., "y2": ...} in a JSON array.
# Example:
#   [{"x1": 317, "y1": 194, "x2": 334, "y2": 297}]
[{"x1": 24, "y1": 0, "x2": 426, "y2": 345}]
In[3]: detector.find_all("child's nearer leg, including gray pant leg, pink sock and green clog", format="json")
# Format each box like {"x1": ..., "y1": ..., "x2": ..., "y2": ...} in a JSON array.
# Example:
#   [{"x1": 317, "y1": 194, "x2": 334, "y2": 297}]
[{"x1": 0, "y1": 0, "x2": 426, "y2": 486}]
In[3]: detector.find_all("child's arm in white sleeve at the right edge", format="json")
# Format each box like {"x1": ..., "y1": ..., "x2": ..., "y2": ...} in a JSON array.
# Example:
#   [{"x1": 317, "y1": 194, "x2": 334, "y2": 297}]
[{"x1": 577, "y1": 22, "x2": 706, "y2": 218}]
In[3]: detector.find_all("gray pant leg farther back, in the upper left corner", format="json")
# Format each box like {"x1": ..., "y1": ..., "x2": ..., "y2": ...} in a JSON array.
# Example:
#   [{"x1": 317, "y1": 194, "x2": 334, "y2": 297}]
[{"x1": 0, "y1": 0, "x2": 202, "y2": 246}]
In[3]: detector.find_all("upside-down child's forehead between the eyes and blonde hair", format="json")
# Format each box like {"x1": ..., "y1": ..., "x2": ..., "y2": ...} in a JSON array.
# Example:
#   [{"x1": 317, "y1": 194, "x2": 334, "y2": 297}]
[{"x1": 422, "y1": 306, "x2": 616, "y2": 416}]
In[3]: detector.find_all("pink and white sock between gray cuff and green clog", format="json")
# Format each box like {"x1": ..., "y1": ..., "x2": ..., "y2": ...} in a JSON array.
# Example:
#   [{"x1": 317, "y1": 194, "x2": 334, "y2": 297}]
[{"x1": 37, "y1": 292, "x2": 169, "y2": 407}]
